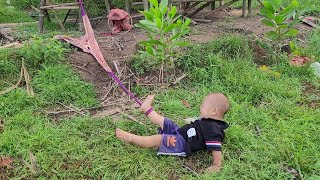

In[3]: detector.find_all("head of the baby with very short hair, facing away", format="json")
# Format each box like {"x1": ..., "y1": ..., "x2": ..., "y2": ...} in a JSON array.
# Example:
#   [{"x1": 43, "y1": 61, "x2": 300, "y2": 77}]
[{"x1": 200, "y1": 93, "x2": 230, "y2": 120}]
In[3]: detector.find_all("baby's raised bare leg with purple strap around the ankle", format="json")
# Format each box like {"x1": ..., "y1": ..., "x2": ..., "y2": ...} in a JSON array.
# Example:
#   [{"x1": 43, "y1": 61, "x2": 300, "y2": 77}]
[{"x1": 141, "y1": 95, "x2": 164, "y2": 129}]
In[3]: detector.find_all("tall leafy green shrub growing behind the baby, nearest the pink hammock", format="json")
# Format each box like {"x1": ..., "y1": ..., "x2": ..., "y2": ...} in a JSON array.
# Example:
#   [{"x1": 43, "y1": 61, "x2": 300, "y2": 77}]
[{"x1": 136, "y1": 0, "x2": 191, "y2": 71}]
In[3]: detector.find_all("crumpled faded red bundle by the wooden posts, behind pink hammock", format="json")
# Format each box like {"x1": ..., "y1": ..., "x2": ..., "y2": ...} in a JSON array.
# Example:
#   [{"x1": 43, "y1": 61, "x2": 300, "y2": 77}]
[{"x1": 108, "y1": 9, "x2": 132, "y2": 34}]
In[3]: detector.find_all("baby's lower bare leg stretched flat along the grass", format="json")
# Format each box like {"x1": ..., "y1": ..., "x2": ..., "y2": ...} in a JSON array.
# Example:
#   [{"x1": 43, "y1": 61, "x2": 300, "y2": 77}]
[{"x1": 116, "y1": 128, "x2": 162, "y2": 148}]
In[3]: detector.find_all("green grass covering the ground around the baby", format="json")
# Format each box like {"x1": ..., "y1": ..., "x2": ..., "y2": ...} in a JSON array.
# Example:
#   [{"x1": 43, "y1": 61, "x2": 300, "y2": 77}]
[{"x1": 0, "y1": 0, "x2": 320, "y2": 180}]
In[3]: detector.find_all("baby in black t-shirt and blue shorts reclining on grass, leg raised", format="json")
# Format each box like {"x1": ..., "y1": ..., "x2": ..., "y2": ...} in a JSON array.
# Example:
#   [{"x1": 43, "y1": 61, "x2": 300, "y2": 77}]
[{"x1": 116, "y1": 93, "x2": 230, "y2": 172}]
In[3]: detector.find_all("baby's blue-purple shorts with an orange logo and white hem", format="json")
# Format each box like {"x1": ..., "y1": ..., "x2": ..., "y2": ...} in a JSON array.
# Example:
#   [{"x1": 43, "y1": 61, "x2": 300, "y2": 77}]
[{"x1": 157, "y1": 118, "x2": 187, "y2": 156}]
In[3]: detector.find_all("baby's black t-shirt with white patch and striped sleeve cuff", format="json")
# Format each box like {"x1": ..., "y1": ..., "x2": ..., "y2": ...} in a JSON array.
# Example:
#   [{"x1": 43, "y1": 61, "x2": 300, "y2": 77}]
[{"x1": 179, "y1": 118, "x2": 229, "y2": 155}]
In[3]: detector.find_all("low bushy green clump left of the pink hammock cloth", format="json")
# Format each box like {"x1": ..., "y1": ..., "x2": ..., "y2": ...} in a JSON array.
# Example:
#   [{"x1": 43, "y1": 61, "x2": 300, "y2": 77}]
[{"x1": 21, "y1": 36, "x2": 67, "y2": 68}]
